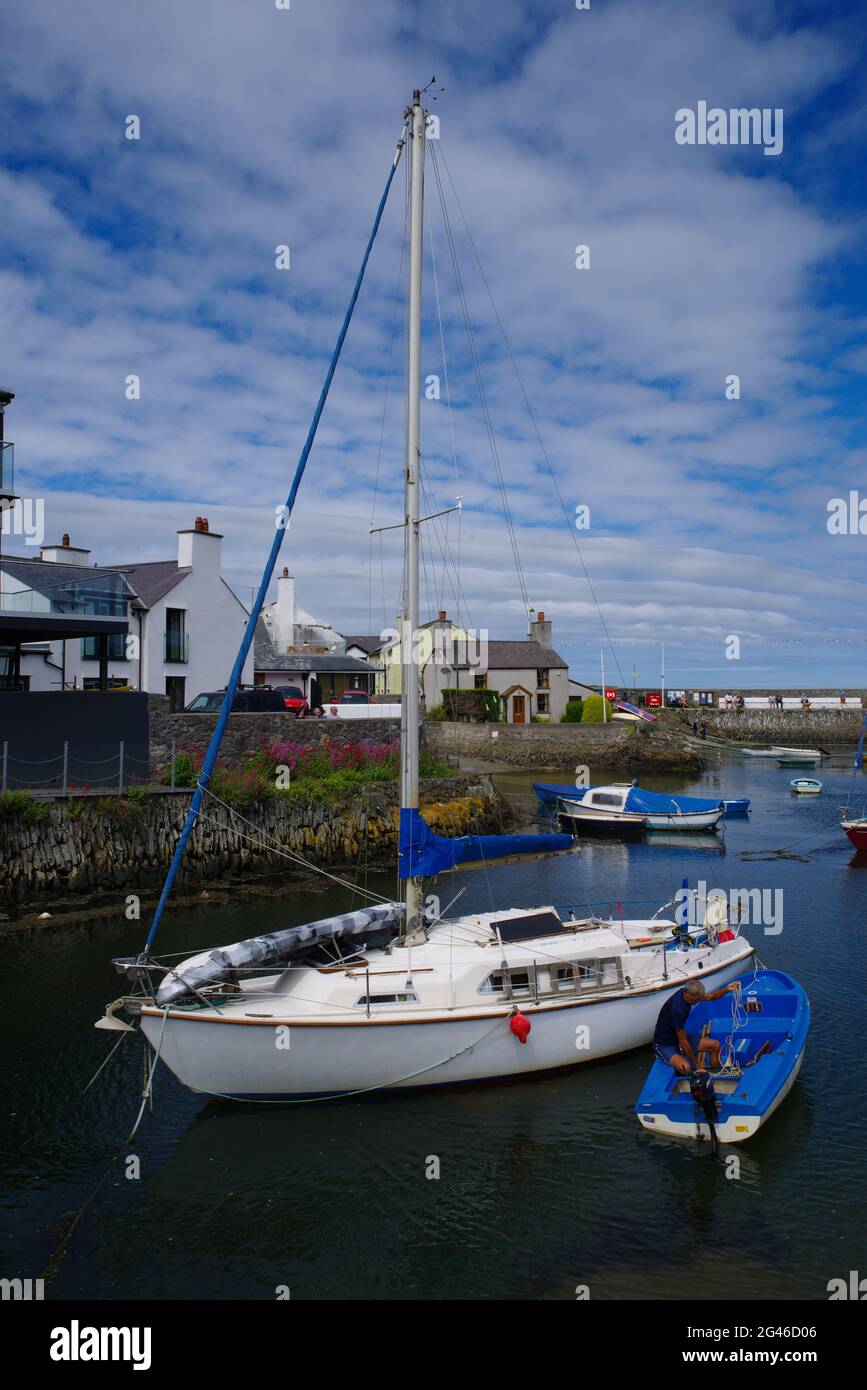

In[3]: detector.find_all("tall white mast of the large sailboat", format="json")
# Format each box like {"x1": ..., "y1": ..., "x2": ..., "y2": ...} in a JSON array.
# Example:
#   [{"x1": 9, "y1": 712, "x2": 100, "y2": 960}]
[{"x1": 400, "y1": 92, "x2": 425, "y2": 937}]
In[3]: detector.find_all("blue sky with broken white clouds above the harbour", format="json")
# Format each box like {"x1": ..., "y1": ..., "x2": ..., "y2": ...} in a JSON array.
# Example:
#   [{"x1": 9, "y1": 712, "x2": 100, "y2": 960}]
[{"x1": 0, "y1": 0, "x2": 867, "y2": 687}]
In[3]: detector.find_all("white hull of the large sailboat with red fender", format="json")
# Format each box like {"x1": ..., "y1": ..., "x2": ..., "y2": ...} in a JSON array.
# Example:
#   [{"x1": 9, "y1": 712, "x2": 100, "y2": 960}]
[{"x1": 142, "y1": 940, "x2": 753, "y2": 1099}]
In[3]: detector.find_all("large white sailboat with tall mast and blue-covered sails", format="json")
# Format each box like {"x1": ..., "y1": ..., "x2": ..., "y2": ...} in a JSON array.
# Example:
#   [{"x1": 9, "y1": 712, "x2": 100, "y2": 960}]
[{"x1": 97, "y1": 92, "x2": 754, "y2": 1101}]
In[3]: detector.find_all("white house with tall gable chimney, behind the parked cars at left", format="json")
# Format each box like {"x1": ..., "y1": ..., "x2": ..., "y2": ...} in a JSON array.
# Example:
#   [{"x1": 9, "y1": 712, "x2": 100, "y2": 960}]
[{"x1": 0, "y1": 517, "x2": 253, "y2": 709}]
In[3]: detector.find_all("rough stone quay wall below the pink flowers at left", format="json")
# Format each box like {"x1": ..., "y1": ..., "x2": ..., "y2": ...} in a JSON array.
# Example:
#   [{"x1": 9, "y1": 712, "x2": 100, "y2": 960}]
[{"x1": 0, "y1": 778, "x2": 510, "y2": 909}]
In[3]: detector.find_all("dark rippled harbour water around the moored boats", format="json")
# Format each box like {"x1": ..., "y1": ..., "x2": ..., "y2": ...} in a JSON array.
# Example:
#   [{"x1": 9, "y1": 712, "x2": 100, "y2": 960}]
[{"x1": 0, "y1": 753, "x2": 867, "y2": 1300}]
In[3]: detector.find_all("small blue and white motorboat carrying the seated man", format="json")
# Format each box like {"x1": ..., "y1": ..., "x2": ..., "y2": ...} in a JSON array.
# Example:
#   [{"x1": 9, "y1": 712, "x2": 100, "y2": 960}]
[{"x1": 635, "y1": 970, "x2": 810, "y2": 1145}]
